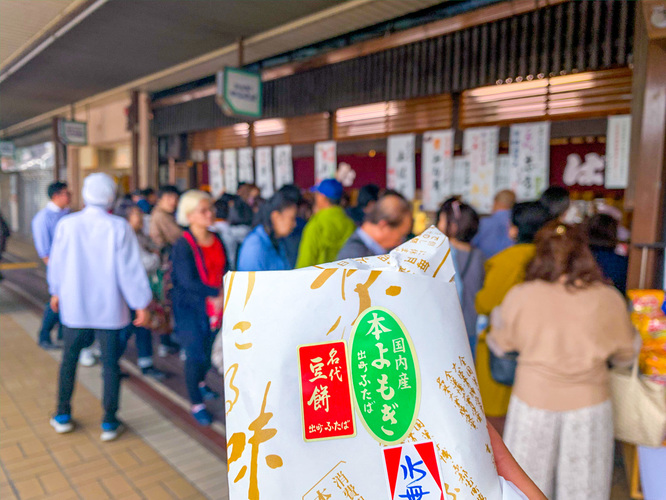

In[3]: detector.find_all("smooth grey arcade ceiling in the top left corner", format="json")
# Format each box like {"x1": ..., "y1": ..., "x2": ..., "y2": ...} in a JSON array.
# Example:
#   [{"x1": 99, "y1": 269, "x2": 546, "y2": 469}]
[{"x1": 0, "y1": 0, "x2": 343, "y2": 129}]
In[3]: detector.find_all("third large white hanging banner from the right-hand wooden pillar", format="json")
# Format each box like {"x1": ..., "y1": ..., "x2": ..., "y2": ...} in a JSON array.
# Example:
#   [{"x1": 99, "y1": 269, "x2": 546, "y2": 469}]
[{"x1": 463, "y1": 127, "x2": 499, "y2": 214}]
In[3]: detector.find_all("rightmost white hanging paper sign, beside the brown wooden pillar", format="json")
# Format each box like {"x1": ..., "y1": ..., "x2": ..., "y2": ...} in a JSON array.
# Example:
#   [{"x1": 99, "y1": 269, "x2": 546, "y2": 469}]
[{"x1": 605, "y1": 115, "x2": 631, "y2": 189}]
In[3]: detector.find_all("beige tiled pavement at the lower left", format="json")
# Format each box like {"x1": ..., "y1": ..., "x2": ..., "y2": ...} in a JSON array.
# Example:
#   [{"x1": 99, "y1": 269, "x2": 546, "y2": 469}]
[{"x1": 0, "y1": 288, "x2": 228, "y2": 500}]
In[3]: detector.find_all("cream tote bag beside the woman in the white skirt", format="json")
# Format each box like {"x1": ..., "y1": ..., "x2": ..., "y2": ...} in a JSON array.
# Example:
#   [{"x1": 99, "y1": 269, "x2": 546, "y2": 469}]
[{"x1": 611, "y1": 362, "x2": 666, "y2": 447}]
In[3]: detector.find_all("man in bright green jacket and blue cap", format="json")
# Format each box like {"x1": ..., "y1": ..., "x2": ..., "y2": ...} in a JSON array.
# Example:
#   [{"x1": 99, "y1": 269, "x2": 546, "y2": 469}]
[{"x1": 296, "y1": 179, "x2": 356, "y2": 268}]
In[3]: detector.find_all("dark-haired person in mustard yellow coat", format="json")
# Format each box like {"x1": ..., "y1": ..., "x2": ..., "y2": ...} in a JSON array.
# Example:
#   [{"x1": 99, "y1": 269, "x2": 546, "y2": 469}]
[{"x1": 475, "y1": 202, "x2": 549, "y2": 429}]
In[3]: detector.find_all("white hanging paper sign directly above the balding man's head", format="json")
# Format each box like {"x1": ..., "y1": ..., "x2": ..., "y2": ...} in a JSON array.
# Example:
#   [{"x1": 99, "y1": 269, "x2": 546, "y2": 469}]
[{"x1": 386, "y1": 134, "x2": 416, "y2": 200}]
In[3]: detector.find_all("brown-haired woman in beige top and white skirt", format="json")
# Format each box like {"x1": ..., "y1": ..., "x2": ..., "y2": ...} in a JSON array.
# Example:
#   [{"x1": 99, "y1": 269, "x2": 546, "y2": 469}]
[{"x1": 488, "y1": 222, "x2": 635, "y2": 500}]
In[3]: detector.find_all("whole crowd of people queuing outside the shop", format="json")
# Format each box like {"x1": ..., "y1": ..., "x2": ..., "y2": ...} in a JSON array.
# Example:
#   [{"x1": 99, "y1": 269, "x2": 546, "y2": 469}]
[{"x1": 33, "y1": 174, "x2": 636, "y2": 498}]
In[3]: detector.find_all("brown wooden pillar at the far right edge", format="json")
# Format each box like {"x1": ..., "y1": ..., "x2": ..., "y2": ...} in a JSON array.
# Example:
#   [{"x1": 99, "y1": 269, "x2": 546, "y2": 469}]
[{"x1": 627, "y1": 0, "x2": 666, "y2": 288}]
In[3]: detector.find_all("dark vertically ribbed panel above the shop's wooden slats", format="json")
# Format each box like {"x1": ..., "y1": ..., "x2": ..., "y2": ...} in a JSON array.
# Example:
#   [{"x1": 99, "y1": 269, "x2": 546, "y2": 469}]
[{"x1": 153, "y1": 1, "x2": 635, "y2": 136}]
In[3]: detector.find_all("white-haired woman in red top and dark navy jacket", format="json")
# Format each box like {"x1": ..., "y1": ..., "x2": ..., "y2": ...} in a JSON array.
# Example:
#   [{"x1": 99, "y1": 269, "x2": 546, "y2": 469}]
[{"x1": 171, "y1": 190, "x2": 227, "y2": 425}]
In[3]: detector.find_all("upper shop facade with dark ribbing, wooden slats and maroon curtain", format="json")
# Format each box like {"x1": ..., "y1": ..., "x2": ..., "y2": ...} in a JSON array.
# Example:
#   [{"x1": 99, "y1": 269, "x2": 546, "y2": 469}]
[{"x1": 153, "y1": 2, "x2": 635, "y2": 212}]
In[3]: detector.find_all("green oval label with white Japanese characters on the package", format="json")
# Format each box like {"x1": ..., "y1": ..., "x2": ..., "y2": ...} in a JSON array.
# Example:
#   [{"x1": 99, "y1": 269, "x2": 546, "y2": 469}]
[{"x1": 349, "y1": 307, "x2": 421, "y2": 444}]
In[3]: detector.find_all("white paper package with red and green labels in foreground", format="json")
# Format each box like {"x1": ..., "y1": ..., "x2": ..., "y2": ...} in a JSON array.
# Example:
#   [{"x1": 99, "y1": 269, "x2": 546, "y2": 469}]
[{"x1": 221, "y1": 228, "x2": 510, "y2": 500}]
